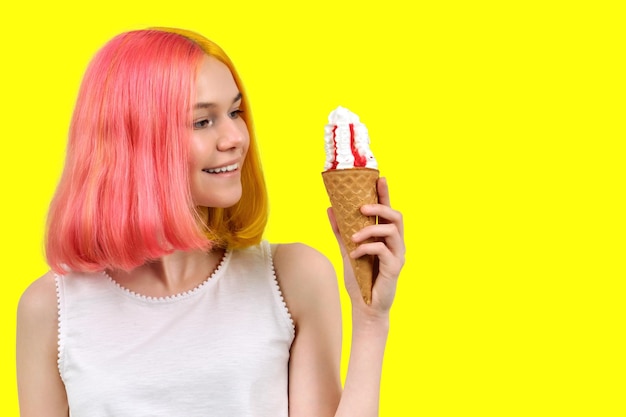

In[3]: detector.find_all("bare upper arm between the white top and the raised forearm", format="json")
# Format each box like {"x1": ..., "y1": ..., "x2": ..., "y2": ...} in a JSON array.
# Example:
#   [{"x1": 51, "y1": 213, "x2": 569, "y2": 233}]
[{"x1": 274, "y1": 244, "x2": 342, "y2": 417}]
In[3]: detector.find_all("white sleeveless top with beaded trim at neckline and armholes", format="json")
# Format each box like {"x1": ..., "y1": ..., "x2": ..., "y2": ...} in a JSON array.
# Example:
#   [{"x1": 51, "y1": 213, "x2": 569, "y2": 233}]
[{"x1": 57, "y1": 242, "x2": 294, "y2": 417}]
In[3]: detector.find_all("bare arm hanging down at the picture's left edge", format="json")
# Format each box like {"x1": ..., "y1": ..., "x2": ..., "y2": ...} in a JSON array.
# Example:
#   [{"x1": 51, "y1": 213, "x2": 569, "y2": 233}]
[{"x1": 16, "y1": 273, "x2": 69, "y2": 417}]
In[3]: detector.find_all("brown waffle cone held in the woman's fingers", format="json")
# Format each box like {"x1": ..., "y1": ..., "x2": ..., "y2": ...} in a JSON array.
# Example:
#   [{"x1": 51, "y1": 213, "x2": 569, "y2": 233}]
[{"x1": 322, "y1": 168, "x2": 378, "y2": 304}]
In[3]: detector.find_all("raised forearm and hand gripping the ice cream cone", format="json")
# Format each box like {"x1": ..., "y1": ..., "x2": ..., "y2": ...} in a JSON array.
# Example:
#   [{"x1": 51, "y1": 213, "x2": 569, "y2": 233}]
[{"x1": 328, "y1": 178, "x2": 406, "y2": 417}]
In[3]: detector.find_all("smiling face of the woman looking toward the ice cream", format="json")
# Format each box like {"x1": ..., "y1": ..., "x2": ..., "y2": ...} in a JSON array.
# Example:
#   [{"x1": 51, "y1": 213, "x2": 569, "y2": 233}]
[{"x1": 189, "y1": 56, "x2": 250, "y2": 208}]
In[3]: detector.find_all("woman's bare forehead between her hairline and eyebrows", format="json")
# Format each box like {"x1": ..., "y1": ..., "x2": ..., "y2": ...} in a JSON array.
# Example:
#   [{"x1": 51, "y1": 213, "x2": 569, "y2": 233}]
[{"x1": 196, "y1": 55, "x2": 239, "y2": 104}]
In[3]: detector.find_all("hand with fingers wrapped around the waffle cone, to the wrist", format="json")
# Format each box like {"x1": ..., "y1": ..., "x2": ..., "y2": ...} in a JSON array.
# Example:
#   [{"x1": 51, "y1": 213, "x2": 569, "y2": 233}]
[{"x1": 328, "y1": 178, "x2": 406, "y2": 313}]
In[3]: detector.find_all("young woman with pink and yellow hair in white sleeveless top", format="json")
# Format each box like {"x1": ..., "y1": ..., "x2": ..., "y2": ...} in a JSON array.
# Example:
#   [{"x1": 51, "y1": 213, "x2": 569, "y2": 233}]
[{"x1": 17, "y1": 28, "x2": 405, "y2": 417}]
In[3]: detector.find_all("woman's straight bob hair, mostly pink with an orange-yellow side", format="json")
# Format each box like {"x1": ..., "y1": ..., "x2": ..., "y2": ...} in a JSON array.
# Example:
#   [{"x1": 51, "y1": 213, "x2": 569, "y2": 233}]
[{"x1": 46, "y1": 30, "x2": 267, "y2": 273}]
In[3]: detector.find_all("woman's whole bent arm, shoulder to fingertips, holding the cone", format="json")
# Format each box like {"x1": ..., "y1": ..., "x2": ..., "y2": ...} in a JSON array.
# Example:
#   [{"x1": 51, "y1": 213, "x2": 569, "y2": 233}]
[{"x1": 274, "y1": 176, "x2": 404, "y2": 417}]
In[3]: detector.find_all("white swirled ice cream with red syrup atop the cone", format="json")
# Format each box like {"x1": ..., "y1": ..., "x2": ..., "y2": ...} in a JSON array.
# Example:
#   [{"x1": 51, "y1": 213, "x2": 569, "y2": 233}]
[{"x1": 324, "y1": 106, "x2": 378, "y2": 171}]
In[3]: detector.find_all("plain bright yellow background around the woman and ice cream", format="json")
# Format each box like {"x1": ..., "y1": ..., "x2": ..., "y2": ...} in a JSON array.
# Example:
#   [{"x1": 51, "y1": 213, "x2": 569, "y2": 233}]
[{"x1": 0, "y1": 0, "x2": 626, "y2": 417}]
